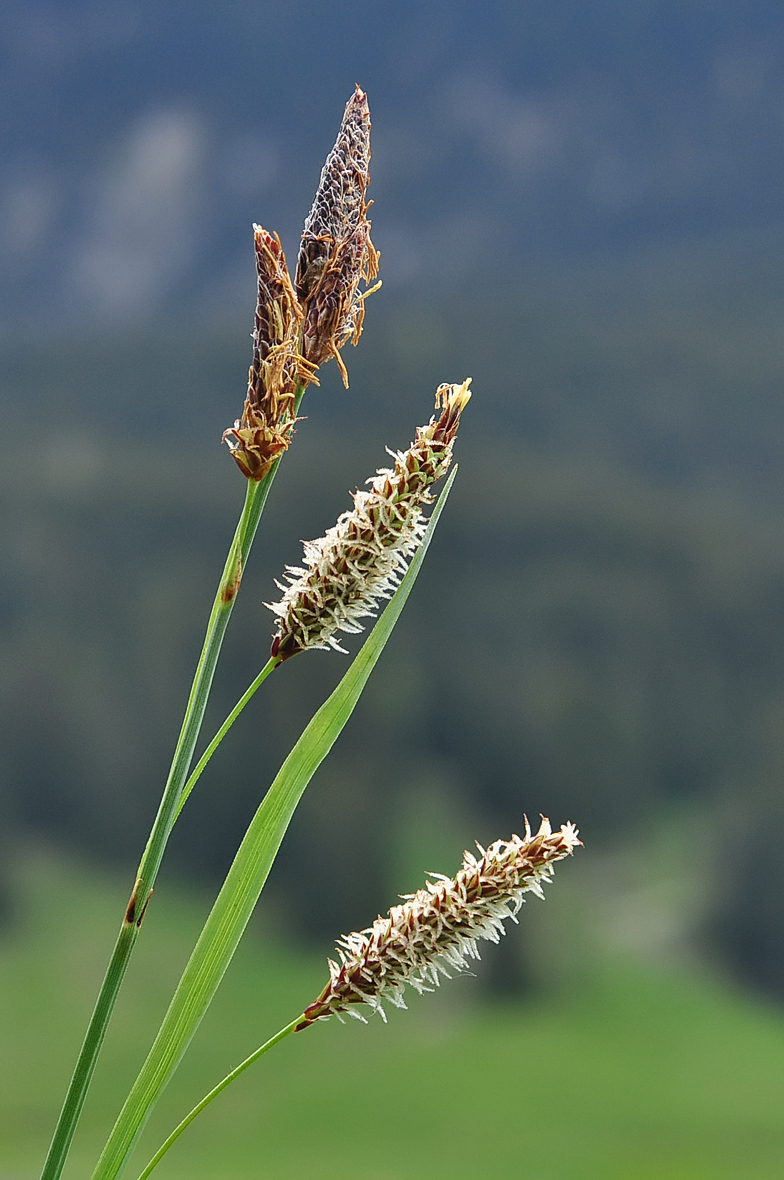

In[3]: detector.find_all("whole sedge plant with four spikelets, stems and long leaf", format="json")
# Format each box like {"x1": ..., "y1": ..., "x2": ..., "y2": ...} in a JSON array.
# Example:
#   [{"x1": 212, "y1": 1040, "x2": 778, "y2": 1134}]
[{"x1": 41, "y1": 86, "x2": 580, "y2": 1180}]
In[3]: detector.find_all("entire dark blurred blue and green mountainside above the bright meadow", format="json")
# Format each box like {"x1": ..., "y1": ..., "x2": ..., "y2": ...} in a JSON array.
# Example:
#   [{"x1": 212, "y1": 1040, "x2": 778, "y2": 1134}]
[{"x1": 0, "y1": 0, "x2": 784, "y2": 995}]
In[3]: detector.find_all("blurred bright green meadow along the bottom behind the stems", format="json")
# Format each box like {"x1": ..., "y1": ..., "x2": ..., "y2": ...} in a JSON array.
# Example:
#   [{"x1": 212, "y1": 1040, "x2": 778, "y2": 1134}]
[{"x1": 0, "y1": 853, "x2": 784, "y2": 1180}]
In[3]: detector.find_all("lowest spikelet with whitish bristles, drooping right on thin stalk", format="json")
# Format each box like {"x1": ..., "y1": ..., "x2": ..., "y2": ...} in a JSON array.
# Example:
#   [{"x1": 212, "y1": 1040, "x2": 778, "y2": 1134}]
[{"x1": 298, "y1": 818, "x2": 580, "y2": 1031}]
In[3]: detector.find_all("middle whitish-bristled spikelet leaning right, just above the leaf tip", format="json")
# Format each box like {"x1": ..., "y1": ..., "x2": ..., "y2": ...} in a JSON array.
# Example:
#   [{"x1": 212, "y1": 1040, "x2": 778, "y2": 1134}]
[{"x1": 266, "y1": 378, "x2": 471, "y2": 661}]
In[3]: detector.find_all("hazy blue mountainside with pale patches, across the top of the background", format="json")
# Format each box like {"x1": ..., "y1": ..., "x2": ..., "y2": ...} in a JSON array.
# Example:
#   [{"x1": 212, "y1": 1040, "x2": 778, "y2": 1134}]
[{"x1": 0, "y1": 0, "x2": 784, "y2": 323}]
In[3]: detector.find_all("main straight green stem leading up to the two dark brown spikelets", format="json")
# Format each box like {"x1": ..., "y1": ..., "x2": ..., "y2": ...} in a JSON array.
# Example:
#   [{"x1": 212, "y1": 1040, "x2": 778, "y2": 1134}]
[{"x1": 41, "y1": 386, "x2": 305, "y2": 1180}]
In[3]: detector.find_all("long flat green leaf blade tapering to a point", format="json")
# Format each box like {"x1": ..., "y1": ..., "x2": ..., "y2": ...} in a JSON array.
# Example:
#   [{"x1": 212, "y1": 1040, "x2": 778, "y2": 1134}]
[{"x1": 93, "y1": 467, "x2": 457, "y2": 1180}]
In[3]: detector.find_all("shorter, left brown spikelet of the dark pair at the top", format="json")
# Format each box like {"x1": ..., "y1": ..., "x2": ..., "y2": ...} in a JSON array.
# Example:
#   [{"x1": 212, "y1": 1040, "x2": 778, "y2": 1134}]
[{"x1": 223, "y1": 225, "x2": 315, "y2": 480}]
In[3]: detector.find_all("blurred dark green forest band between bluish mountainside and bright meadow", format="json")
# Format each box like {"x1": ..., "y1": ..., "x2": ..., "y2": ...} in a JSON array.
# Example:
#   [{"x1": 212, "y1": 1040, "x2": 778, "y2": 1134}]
[{"x1": 0, "y1": 242, "x2": 784, "y2": 990}]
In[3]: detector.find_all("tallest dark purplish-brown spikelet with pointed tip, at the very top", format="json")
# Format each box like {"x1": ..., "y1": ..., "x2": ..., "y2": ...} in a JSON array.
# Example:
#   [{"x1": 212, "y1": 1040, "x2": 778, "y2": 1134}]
[{"x1": 296, "y1": 86, "x2": 380, "y2": 386}]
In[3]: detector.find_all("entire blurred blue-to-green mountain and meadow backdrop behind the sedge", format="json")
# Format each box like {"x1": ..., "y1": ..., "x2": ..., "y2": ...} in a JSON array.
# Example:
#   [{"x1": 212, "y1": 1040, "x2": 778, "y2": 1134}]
[{"x1": 0, "y1": 0, "x2": 784, "y2": 1180}]
